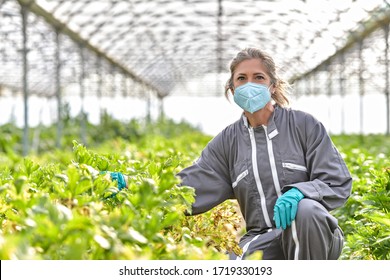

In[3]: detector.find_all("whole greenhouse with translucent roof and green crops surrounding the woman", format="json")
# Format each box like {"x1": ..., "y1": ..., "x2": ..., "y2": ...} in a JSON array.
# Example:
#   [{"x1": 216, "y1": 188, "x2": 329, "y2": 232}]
[{"x1": 0, "y1": 0, "x2": 390, "y2": 270}]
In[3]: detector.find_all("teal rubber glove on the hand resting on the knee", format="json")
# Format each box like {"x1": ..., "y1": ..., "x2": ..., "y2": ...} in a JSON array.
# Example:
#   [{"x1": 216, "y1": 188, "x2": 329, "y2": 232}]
[{"x1": 274, "y1": 188, "x2": 305, "y2": 229}]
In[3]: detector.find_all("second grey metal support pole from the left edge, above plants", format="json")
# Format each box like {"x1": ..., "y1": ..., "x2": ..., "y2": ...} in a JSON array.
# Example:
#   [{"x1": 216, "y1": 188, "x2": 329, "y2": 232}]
[{"x1": 55, "y1": 30, "x2": 63, "y2": 149}]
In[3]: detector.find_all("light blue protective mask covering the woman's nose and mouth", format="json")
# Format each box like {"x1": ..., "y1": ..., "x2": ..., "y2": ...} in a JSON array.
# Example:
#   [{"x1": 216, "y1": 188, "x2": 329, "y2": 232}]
[{"x1": 233, "y1": 82, "x2": 271, "y2": 114}]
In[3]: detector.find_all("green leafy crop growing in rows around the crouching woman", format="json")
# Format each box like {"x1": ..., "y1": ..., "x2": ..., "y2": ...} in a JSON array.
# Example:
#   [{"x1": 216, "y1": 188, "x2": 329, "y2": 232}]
[{"x1": 0, "y1": 115, "x2": 390, "y2": 259}]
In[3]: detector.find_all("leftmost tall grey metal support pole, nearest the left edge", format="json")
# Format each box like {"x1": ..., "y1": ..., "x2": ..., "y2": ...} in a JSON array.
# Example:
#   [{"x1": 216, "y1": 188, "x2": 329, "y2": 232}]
[{"x1": 21, "y1": 6, "x2": 29, "y2": 156}]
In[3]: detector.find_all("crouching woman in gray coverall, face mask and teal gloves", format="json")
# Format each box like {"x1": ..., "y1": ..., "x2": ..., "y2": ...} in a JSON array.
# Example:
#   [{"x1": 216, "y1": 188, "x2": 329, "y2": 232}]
[{"x1": 178, "y1": 48, "x2": 352, "y2": 260}]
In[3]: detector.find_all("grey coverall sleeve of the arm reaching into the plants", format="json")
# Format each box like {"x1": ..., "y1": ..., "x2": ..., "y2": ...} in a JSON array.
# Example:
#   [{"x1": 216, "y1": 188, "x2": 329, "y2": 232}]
[{"x1": 177, "y1": 134, "x2": 234, "y2": 215}]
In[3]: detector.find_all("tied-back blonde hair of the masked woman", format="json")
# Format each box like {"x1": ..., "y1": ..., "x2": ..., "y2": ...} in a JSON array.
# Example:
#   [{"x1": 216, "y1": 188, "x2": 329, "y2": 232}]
[{"x1": 225, "y1": 48, "x2": 291, "y2": 107}]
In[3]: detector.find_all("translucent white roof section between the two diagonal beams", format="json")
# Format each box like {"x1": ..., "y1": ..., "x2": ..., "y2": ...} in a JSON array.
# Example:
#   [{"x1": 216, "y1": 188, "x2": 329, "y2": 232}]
[{"x1": 2, "y1": 0, "x2": 390, "y2": 95}]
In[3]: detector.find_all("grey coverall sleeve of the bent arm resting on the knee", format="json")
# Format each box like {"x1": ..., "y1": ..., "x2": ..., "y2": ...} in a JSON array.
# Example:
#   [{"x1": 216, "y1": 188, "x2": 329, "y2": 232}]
[{"x1": 283, "y1": 116, "x2": 352, "y2": 211}]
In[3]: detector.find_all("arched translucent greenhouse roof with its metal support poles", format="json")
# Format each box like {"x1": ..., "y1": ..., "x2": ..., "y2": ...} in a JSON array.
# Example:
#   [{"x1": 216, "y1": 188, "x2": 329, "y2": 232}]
[{"x1": 0, "y1": 0, "x2": 390, "y2": 153}]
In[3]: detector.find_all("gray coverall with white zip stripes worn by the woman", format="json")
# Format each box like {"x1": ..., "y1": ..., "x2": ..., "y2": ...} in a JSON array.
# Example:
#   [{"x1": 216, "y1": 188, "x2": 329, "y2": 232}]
[{"x1": 178, "y1": 105, "x2": 352, "y2": 260}]
